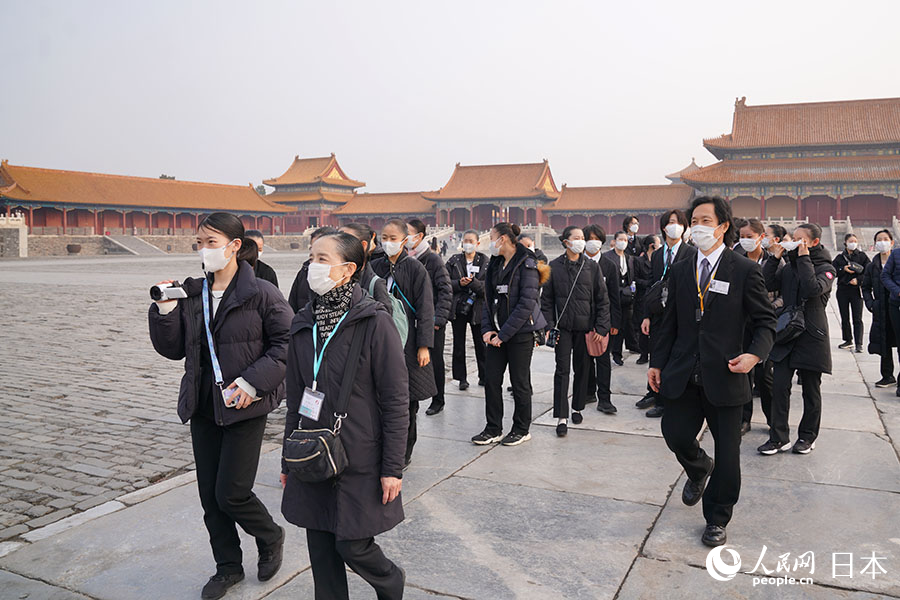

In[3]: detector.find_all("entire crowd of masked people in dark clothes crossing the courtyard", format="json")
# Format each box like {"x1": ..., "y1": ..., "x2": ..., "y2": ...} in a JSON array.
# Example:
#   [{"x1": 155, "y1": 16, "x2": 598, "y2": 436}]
[{"x1": 149, "y1": 203, "x2": 900, "y2": 598}]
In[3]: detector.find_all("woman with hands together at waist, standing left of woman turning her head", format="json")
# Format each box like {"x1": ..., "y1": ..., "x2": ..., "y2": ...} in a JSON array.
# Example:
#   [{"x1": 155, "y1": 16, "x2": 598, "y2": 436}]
[{"x1": 447, "y1": 229, "x2": 488, "y2": 390}]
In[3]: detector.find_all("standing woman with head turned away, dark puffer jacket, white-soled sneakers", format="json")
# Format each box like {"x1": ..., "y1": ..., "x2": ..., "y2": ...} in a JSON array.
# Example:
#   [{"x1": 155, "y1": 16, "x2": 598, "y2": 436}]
[{"x1": 472, "y1": 223, "x2": 550, "y2": 446}]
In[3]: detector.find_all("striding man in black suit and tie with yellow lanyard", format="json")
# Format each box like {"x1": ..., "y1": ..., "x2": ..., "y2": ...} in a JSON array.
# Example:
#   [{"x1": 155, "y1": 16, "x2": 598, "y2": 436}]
[{"x1": 647, "y1": 196, "x2": 775, "y2": 547}]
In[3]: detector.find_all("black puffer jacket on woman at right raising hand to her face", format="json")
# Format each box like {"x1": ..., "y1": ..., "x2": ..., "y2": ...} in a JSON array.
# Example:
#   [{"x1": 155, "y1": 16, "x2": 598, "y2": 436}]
[{"x1": 763, "y1": 244, "x2": 836, "y2": 373}]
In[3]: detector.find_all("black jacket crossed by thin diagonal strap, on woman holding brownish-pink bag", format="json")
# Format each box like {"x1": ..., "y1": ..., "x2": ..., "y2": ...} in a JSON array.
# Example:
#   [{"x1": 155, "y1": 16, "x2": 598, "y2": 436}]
[{"x1": 541, "y1": 254, "x2": 610, "y2": 335}]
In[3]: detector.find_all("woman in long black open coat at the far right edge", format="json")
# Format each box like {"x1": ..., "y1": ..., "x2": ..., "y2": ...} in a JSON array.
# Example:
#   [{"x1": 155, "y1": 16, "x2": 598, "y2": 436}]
[{"x1": 862, "y1": 229, "x2": 900, "y2": 387}]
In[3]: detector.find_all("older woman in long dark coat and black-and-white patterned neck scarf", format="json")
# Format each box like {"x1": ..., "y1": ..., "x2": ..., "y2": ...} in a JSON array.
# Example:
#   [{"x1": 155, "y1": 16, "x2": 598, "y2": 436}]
[{"x1": 281, "y1": 233, "x2": 409, "y2": 599}]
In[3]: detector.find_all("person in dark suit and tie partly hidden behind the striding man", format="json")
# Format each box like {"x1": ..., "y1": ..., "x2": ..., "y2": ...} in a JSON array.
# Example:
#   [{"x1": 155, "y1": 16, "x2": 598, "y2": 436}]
[{"x1": 635, "y1": 208, "x2": 697, "y2": 418}]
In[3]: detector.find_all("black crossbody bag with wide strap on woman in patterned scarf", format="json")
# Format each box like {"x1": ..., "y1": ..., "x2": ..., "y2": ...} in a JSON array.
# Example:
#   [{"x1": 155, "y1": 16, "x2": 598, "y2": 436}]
[{"x1": 281, "y1": 322, "x2": 367, "y2": 483}]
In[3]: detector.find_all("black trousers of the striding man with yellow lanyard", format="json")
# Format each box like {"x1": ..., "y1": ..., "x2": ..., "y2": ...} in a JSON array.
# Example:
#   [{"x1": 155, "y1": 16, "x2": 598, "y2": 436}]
[{"x1": 662, "y1": 383, "x2": 743, "y2": 527}]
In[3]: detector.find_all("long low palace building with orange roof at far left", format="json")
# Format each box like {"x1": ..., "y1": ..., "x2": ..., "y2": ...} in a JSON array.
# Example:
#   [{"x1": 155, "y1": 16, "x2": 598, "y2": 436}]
[{"x1": 0, "y1": 160, "x2": 291, "y2": 235}]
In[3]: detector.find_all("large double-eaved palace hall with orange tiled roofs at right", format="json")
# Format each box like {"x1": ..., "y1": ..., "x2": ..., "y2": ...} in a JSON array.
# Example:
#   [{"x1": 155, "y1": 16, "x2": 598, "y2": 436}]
[{"x1": 681, "y1": 98, "x2": 900, "y2": 226}]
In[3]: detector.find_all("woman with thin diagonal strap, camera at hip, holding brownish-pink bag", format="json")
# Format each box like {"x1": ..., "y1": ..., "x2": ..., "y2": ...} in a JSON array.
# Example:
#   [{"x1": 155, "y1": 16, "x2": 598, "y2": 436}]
[{"x1": 541, "y1": 226, "x2": 609, "y2": 437}]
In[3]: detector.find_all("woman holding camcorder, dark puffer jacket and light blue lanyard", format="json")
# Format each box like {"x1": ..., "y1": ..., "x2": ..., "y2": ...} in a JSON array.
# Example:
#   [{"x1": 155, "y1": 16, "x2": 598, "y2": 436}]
[{"x1": 149, "y1": 213, "x2": 293, "y2": 598}]
